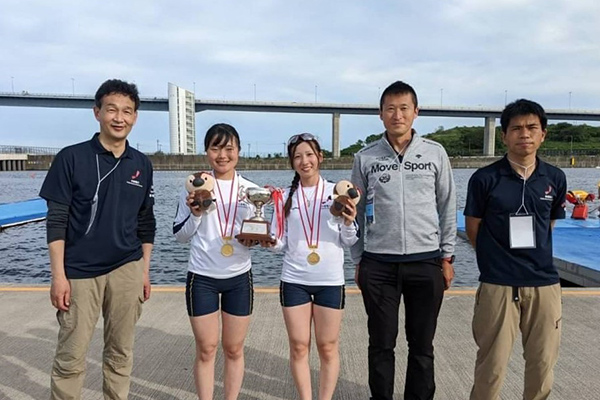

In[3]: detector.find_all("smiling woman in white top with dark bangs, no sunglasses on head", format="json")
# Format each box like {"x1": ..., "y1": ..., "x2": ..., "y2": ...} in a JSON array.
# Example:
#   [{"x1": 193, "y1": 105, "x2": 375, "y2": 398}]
[{"x1": 173, "y1": 124, "x2": 257, "y2": 399}]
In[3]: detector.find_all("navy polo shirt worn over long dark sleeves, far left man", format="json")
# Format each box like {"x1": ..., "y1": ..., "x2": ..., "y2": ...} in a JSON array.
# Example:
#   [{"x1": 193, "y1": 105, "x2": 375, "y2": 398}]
[{"x1": 40, "y1": 133, "x2": 154, "y2": 279}]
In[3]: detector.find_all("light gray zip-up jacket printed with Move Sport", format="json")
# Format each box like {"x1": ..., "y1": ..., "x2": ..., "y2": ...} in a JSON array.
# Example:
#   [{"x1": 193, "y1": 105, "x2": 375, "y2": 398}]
[{"x1": 351, "y1": 131, "x2": 456, "y2": 264}]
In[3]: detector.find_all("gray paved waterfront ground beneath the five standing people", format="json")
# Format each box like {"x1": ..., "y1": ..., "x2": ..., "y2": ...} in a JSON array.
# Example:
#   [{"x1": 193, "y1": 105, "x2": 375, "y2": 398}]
[{"x1": 0, "y1": 286, "x2": 600, "y2": 400}]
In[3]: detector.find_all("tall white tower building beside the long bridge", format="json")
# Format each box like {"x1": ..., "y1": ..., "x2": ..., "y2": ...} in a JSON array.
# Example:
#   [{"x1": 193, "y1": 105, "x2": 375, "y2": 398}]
[{"x1": 169, "y1": 82, "x2": 196, "y2": 154}]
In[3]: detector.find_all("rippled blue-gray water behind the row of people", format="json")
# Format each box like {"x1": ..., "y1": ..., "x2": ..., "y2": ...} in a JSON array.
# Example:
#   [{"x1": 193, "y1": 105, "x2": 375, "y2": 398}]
[{"x1": 0, "y1": 169, "x2": 600, "y2": 286}]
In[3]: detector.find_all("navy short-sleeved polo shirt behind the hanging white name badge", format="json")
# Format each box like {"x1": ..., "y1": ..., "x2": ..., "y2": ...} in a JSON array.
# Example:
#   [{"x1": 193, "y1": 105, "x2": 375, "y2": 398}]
[{"x1": 464, "y1": 156, "x2": 567, "y2": 287}]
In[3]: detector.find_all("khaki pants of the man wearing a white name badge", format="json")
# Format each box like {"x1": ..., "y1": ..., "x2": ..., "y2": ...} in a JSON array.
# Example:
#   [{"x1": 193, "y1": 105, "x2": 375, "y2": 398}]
[{"x1": 470, "y1": 283, "x2": 562, "y2": 400}]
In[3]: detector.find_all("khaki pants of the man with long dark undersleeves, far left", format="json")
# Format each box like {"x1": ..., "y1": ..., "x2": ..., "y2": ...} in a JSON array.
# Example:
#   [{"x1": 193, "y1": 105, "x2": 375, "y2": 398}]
[{"x1": 50, "y1": 259, "x2": 144, "y2": 400}]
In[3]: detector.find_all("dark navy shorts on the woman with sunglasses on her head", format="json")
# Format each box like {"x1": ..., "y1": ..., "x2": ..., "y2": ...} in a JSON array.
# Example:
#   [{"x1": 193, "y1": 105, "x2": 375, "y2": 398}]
[{"x1": 279, "y1": 281, "x2": 346, "y2": 310}]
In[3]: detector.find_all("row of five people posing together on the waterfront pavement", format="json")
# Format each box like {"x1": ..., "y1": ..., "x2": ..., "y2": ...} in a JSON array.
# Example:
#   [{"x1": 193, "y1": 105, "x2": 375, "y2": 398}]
[{"x1": 40, "y1": 80, "x2": 566, "y2": 400}]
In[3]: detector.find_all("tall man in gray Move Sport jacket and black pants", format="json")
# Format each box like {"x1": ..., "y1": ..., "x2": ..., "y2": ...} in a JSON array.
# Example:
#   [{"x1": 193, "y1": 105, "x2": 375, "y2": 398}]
[{"x1": 351, "y1": 81, "x2": 456, "y2": 400}]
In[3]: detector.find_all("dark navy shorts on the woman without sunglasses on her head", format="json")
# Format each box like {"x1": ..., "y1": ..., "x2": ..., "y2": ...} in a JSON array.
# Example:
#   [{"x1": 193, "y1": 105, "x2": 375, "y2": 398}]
[{"x1": 185, "y1": 270, "x2": 254, "y2": 317}]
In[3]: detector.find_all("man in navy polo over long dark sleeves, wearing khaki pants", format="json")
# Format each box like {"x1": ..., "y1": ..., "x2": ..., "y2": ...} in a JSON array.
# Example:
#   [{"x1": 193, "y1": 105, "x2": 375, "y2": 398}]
[{"x1": 40, "y1": 79, "x2": 156, "y2": 399}]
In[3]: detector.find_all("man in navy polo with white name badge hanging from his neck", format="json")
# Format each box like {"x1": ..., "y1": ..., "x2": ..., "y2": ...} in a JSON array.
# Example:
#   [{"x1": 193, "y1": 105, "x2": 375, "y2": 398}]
[{"x1": 464, "y1": 99, "x2": 567, "y2": 400}]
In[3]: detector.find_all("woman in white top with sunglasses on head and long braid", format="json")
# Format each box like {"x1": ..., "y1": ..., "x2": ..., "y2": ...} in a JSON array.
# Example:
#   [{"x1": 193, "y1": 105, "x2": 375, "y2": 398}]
[{"x1": 261, "y1": 133, "x2": 358, "y2": 399}]
